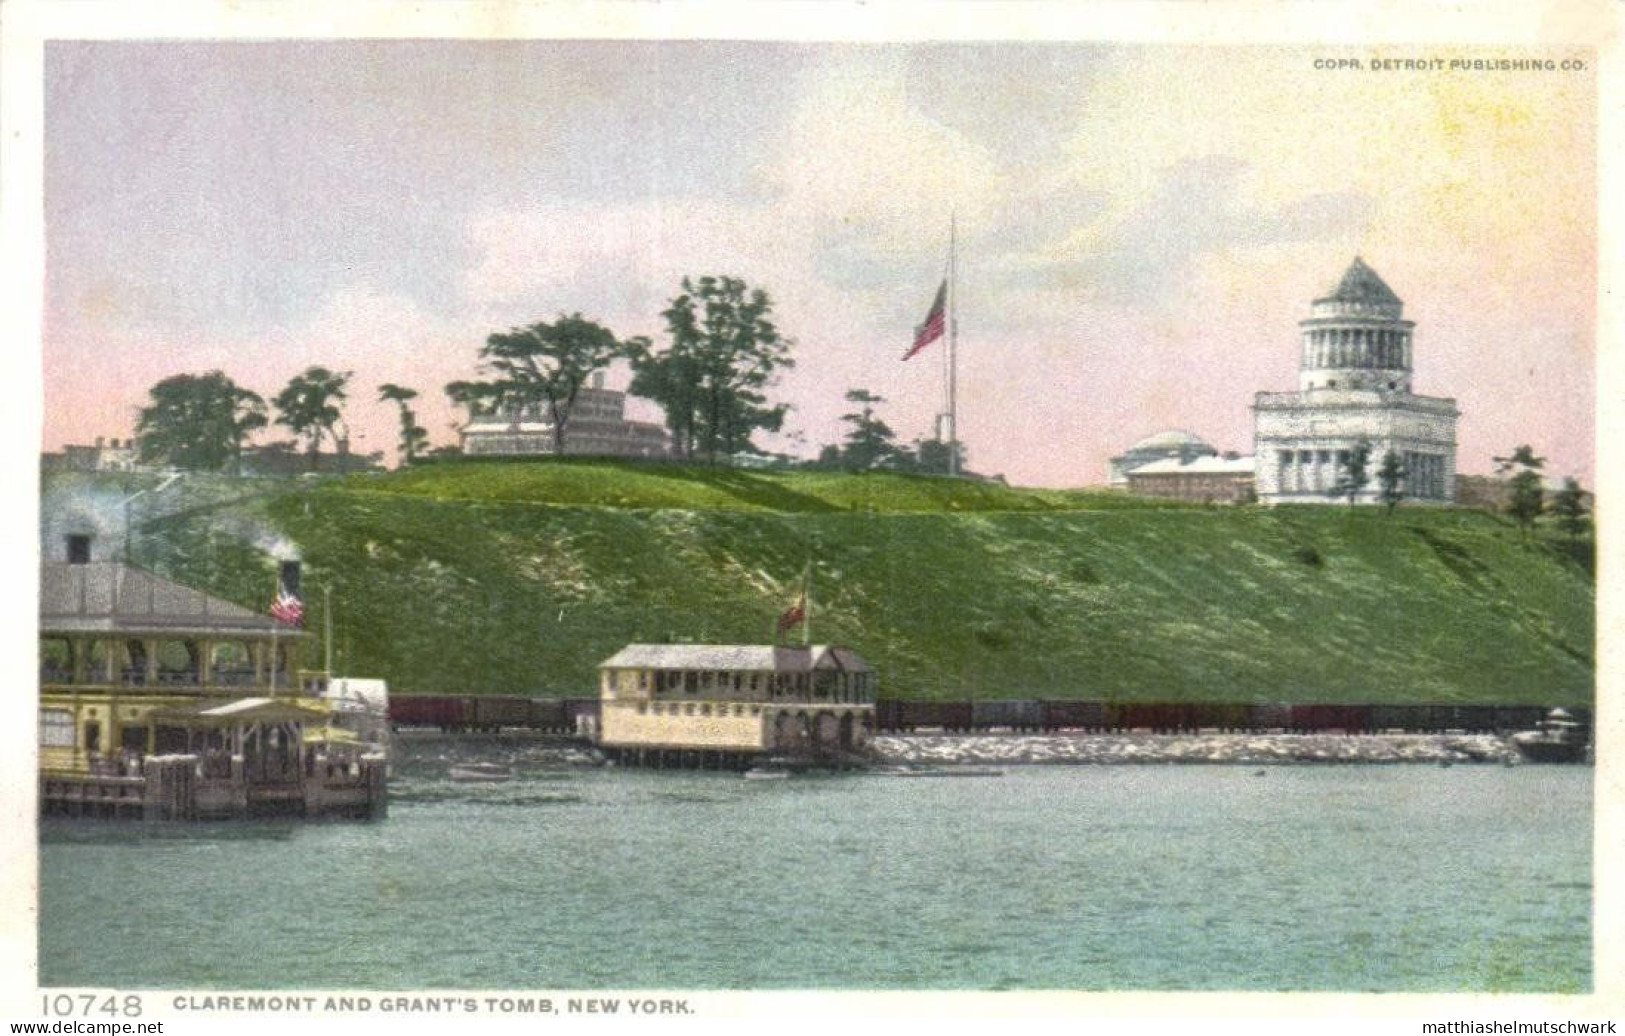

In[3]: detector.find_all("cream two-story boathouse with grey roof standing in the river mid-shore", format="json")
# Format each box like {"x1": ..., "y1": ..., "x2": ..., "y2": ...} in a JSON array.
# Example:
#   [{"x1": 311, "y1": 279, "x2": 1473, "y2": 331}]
[{"x1": 598, "y1": 645, "x2": 876, "y2": 768}]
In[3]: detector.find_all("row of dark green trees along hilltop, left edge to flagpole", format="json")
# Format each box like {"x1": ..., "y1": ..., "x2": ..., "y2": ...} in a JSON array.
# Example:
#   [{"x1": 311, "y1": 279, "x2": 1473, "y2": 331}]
[{"x1": 126, "y1": 276, "x2": 964, "y2": 483}]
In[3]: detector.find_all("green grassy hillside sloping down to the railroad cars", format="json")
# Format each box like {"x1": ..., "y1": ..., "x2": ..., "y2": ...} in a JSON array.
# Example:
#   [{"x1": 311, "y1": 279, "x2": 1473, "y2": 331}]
[{"x1": 73, "y1": 461, "x2": 1594, "y2": 705}]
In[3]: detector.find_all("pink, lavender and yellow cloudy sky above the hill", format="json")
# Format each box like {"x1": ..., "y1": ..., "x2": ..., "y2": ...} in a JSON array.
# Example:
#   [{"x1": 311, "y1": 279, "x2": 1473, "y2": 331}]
[{"x1": 42, "y1": 41, "x2": 1597, "y2": 486}]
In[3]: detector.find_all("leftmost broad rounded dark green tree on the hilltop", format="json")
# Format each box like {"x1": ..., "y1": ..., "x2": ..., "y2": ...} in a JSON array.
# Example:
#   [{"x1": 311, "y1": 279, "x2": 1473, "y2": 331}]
[{"x1": 135, "y1": 370, "x2": 265, "y2": 474}]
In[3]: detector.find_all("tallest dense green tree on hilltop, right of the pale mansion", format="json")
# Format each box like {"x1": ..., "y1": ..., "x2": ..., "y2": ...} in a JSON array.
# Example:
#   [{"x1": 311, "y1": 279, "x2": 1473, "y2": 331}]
[{"x1": 631, "y1": 276, "x2": 795, "y2": 463}]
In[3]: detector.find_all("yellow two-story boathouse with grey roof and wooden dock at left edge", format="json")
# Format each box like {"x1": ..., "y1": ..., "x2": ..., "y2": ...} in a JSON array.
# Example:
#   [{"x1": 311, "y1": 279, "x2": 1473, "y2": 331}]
[{"x1": 39, "y1": 552, "x2": 385, "y2": 820}]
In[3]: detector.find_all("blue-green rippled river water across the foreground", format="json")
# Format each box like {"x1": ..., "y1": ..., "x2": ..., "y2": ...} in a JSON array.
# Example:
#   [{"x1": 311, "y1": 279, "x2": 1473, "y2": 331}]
[{"x1": 39, "y1": 742, "x2": 1593, "y2": 992}]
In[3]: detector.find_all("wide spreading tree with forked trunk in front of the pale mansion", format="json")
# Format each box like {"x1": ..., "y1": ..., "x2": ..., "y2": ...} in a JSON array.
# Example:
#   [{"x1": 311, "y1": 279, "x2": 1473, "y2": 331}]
[{"x1": 474, "y1": 313, "x2": 645, "y2": 455}]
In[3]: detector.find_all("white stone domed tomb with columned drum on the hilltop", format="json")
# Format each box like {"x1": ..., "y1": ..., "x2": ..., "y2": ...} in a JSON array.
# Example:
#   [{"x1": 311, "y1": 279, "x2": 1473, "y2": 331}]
[{"x1": 1253, "y1": 257, "x2": 1459, "y2": 503}]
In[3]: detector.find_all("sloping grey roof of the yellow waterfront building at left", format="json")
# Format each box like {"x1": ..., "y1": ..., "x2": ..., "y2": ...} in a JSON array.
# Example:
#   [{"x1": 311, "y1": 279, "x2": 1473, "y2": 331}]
[{"x1": 39, "y1": 562, "x2": 309, "y2": 637}]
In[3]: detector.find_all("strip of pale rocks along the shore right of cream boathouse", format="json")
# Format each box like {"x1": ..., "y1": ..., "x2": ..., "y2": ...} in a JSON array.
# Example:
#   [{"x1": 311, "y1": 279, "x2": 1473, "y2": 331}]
[{"x1": 869, "y1": 734, "x2": 1523, "y2": 766}]
